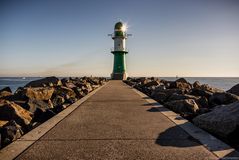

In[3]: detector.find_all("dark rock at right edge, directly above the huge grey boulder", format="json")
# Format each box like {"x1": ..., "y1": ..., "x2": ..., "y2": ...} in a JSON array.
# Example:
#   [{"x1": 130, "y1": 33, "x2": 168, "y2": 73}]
[{"x1": 209, "y1": 92, "x2": 239, "y2": 106}]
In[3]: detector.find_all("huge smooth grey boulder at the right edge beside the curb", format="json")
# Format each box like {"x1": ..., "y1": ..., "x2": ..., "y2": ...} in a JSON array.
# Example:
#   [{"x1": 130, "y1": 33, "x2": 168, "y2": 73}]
[{"x1": 193, "y1": 102, "x2": 239, "y2": 138}]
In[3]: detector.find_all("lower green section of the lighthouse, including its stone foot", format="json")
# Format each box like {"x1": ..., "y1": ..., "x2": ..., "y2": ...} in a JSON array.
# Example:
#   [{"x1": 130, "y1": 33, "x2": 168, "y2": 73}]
[{"x1": 111, "y1": 51, "x2": 128, "y2": 80}]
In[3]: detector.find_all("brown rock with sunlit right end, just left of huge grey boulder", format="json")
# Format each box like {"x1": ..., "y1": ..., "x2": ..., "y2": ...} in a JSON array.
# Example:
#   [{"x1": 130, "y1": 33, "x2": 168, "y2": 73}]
[{"x1": 164, "y1": 99, "x2": 199, "y2": 114}]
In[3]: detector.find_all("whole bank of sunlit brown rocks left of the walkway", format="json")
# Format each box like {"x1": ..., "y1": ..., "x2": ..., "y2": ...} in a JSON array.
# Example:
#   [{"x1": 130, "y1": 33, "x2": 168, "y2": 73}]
[{"x1": 0, "y1": 77, "x2": 107, "y2": 148}]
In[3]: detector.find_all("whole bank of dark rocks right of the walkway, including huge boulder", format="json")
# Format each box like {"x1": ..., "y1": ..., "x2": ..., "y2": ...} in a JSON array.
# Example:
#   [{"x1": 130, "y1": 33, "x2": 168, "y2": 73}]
[{"x1": 125, "y1": 77, "x2": 239, "y2": 149}]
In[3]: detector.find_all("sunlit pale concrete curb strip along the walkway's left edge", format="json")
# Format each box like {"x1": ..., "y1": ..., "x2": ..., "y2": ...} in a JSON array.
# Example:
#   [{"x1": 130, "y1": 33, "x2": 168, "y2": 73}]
[{"x1": 0, "y1": 81, "x2": 109, "y2": 160}]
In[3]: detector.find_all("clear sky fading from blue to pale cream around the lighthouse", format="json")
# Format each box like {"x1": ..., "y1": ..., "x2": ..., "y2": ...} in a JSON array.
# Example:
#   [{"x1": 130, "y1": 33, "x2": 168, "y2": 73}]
[{"x1": 0, "y1": 0, "x2": 239, "y2": 77}]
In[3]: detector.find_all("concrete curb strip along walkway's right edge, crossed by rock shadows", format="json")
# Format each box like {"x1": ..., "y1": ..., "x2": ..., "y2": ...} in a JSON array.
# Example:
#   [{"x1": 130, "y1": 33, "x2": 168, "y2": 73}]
[{"x1": 132, "y1": 88, "x2": 239, "y2": 159}]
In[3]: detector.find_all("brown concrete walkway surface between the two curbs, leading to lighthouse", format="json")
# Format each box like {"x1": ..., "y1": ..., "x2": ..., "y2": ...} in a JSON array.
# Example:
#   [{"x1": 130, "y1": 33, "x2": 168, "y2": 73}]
[{"x1": 14, "y1": 81, "x2": 216, "y2": 160}]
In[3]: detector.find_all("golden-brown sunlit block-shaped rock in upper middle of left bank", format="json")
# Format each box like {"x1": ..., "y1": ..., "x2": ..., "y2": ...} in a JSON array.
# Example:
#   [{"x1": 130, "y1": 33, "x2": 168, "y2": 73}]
[{"x1": 26, "y1": 87, "x2": 54, "y2": 100}]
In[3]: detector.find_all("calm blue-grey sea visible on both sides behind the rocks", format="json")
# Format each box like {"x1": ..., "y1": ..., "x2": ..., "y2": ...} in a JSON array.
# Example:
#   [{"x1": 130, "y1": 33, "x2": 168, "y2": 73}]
[{"x1": 0, "y1": 77, "x2": 239, "y2": 92}]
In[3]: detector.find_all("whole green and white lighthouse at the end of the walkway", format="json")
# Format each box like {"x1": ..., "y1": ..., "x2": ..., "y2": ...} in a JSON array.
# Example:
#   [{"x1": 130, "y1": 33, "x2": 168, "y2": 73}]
[{"x1": 109, "y1": 22, "x2": 130, "y2": 80}]
